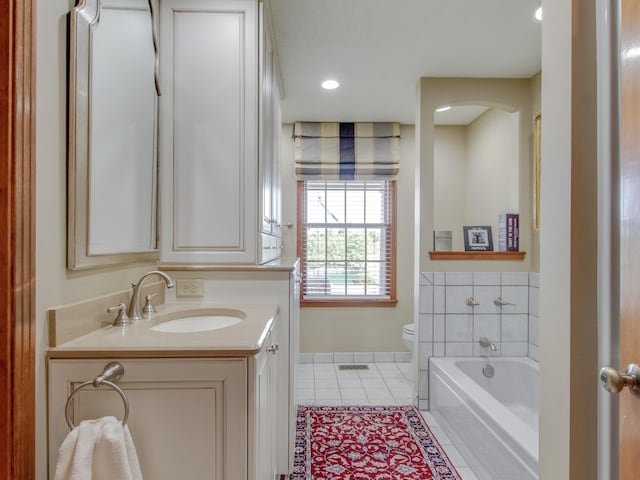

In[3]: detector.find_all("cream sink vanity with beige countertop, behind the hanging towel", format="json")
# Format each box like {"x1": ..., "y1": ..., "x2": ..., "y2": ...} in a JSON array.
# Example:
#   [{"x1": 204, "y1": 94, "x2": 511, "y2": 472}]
[{"x1": 47, "y1": 304, "x2": 280, "y2": 480}]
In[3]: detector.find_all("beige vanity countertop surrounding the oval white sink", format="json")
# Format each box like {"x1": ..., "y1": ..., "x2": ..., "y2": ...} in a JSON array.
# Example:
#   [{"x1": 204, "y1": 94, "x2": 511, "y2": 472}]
[{"x1": 47, "y1": 303, "x2": 278, "y2": 358}]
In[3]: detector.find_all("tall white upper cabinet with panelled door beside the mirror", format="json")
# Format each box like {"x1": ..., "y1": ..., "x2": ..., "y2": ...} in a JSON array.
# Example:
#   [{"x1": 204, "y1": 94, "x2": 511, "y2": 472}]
[{"x1": 159, "y1": 0, "x2": 280, "y2": 265}]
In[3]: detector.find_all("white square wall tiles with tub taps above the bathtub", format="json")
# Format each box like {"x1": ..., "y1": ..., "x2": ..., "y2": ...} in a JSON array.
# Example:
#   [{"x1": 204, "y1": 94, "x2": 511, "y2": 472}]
[{"x1": 417, "y1": 272, "x2": 540, "y2": 409}]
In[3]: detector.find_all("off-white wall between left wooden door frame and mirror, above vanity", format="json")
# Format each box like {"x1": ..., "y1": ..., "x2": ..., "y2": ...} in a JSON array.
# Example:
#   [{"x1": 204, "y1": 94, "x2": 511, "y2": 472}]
[{"x1": 36, "y1": 0, "x2": 152, "y2": 479}]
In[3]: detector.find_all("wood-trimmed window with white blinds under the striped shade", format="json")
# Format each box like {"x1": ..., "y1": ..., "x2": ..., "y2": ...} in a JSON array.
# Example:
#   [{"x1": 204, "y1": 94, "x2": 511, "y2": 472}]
[{"x1": 298, "y1": 180, "x2": 396, "y2": 306}]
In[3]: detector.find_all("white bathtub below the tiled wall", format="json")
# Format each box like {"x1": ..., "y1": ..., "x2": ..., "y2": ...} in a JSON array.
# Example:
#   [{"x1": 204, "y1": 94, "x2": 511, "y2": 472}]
[{"x1": 429, "y1": 357, "x2": 540, "y2": 480}]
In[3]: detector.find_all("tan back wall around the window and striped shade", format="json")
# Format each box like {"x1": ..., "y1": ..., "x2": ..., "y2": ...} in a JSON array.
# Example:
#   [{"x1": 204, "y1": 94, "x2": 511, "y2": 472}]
[{"x1": 281, "y1": 125, "x2": 416, "y2": 352}]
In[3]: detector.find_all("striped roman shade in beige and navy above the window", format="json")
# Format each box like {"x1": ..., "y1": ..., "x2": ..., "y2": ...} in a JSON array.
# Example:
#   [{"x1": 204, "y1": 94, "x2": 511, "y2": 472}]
[{"x1": 293, "y1": 122, "x2": 400, "y2": 180}]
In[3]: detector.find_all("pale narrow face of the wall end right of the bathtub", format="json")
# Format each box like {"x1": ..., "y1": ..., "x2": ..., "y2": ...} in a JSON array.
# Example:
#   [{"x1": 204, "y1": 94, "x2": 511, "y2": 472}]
[{"x1": 540, "y1": 0, "x2": 572, "y2": 480}]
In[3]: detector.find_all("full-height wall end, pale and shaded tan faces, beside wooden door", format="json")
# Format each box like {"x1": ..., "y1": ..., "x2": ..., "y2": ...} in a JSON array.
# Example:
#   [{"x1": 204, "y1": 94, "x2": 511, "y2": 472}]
[{"x1": 540, "y1": 0, "x2": 600, "y2": 480}]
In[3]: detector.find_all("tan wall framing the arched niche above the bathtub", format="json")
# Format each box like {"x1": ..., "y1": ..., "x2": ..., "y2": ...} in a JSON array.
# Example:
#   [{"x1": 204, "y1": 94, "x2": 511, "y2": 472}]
[{"x1": 416, "y1": 78, "x2": 533, "y2": 271}]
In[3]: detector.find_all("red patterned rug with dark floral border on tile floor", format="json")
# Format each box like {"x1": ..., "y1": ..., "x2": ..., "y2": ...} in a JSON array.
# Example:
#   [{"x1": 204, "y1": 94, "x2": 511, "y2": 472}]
[{"x1": 290, "y1": 406, "x2": 461, "y2": 480}]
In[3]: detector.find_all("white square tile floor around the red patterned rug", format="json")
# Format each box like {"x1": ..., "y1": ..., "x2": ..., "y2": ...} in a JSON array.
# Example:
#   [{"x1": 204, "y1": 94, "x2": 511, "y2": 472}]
[{"x1": 296, "y1": 363, "x2": 478, "y2": 480}]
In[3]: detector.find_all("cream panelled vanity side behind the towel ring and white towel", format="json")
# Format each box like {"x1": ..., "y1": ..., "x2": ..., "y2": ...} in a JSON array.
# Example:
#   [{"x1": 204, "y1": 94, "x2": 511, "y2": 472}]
[{"x1": 48, "y1": 359, "x2": 247, "y2": 480}]
